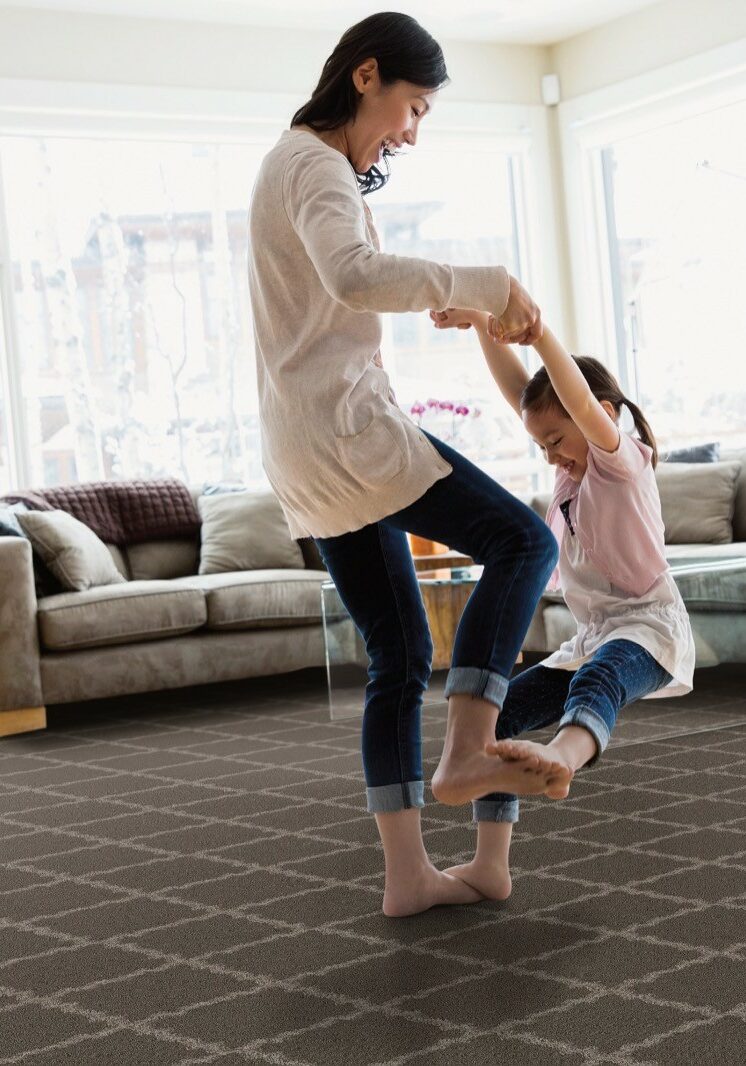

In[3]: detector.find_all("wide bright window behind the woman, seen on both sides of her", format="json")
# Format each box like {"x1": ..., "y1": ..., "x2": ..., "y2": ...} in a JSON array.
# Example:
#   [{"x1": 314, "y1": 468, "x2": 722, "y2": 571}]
[{"x1": 0, "y1": 107, "x2": 544, "y2": 491}]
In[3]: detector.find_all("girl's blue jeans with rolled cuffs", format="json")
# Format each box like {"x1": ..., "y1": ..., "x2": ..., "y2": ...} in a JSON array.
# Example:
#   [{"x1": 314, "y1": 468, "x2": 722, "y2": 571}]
[{"x1": 472, "y1": 641, "x2": 671, "y2": 822}]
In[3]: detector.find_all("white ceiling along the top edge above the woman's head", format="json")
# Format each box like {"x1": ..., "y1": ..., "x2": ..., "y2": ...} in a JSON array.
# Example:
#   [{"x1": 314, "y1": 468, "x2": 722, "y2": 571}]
[{"x1": 12, "y1": 0, "x2": 658, "y2": 45}]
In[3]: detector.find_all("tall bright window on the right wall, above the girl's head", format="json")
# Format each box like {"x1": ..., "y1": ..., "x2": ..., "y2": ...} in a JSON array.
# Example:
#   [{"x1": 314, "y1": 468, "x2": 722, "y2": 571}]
[{"x1": 584, "y1": 94, "x2": 746, "y2": 450}]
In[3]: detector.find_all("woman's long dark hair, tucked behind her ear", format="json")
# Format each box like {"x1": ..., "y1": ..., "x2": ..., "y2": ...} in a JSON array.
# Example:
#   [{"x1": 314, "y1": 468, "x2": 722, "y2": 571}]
[{"x1": 290, "y1": 11, "x2": 449, "y2": 196}]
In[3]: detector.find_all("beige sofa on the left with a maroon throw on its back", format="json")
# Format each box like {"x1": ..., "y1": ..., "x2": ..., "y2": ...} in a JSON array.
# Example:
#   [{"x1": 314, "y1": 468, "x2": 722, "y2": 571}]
[{"x1": 0, "y1": 490, "x2": 328, "y2": 736}]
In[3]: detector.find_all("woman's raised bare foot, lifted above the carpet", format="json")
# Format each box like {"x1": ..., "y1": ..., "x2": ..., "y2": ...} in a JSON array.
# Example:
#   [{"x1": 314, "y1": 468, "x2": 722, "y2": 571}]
[{"x1": 432, "y1": 742, "x2": 569, "y2": 806}]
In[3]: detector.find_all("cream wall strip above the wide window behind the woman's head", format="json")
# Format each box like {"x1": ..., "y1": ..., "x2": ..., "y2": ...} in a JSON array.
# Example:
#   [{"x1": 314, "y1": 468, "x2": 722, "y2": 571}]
[{"x1": 0, "y1": 5, "x2": 549, "y2": 103}]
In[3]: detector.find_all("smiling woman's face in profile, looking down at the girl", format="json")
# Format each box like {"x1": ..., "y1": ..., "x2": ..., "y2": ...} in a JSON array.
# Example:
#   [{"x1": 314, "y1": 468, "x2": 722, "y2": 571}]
[{"x1": 345, "y1": 60, "x2": 437, "y2": 174}]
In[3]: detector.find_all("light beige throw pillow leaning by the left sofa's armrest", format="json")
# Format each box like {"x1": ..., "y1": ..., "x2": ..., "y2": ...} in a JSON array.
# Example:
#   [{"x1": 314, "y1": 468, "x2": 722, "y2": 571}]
[{"x1": 17, "y1": 511, "x2": 127, "y2": 592}]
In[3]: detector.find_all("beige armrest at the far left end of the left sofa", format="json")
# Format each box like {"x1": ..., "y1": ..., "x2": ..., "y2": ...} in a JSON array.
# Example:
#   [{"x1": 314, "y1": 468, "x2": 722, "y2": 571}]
[{"x1": 0, "y1": 536, "x2": 44, "y2": 712}]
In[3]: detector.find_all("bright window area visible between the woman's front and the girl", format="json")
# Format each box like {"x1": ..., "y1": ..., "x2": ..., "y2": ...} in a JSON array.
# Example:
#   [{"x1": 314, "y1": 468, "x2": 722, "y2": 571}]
[{"x1": 369, "y1": 134, "x2": 541, "y2": 492}]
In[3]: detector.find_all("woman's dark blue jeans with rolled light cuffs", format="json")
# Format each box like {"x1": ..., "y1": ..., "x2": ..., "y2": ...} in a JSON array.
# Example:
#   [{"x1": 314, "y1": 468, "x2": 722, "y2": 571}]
[{"x1": 314, "y1": 434, "x2": 557, "y2": 812}]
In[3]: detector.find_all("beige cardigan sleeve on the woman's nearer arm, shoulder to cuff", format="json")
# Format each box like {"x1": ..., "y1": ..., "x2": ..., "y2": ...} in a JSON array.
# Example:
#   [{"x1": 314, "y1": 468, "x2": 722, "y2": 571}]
[{"x1": 281, "y1": 142, "x2": 510, "y2": 317}]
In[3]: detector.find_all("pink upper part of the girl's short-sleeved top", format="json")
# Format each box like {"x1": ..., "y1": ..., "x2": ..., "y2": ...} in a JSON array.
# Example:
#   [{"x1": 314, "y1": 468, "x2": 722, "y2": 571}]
[{"x1": 547, "y1": 433, "x2": 668, "y2": 596}]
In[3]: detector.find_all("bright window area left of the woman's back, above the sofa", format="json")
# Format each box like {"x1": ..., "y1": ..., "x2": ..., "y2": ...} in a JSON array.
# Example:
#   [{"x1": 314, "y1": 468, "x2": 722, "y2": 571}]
[{"x1": 0, "y1": 133, "x2": 274, "y2": 494}]
